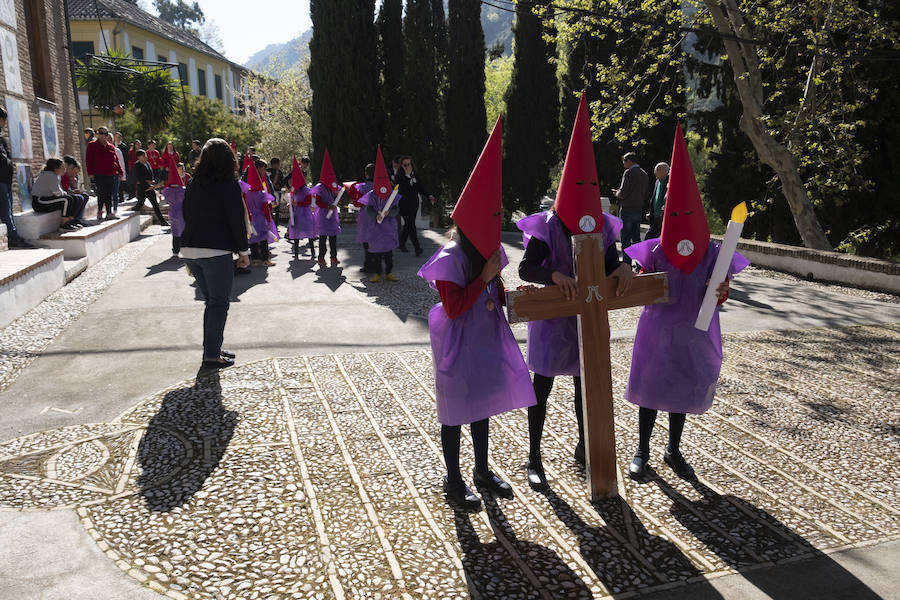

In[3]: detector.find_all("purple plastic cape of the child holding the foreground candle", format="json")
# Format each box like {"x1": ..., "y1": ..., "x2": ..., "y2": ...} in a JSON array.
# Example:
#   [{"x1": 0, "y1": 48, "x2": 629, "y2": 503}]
[{"x1": 625, "y1": 238, "x2": 750, "y2": 414}]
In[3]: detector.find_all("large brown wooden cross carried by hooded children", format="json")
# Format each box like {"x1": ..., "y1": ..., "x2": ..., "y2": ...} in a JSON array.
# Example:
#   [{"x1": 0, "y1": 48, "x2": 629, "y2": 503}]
[{"x1": 507, "y1": 233, "x2": 669, "y2": 500}]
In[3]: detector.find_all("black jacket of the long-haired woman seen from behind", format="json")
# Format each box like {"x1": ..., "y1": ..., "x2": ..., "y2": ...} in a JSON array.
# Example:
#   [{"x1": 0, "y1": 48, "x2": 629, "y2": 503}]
[{"x1": 181, "y1": 179, "x2": 248, "y2": 252}]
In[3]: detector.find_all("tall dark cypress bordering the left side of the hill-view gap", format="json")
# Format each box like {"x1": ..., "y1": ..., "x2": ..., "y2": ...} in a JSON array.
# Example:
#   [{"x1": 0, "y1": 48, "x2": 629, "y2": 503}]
[{"x1": 446, "y1": 0, "x2": 487, "y2": 202}]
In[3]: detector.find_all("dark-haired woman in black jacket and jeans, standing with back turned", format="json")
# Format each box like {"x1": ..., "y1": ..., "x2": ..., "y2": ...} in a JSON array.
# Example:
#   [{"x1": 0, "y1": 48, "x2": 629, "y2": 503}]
[{"x1": 181, "y1": 138, "x2": 250, "y2": 369}]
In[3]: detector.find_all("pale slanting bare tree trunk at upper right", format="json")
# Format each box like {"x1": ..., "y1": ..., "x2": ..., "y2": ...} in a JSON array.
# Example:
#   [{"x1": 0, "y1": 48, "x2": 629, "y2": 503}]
[{"x1": 705, "y1": 0, "x2": 833, "y2": 250}]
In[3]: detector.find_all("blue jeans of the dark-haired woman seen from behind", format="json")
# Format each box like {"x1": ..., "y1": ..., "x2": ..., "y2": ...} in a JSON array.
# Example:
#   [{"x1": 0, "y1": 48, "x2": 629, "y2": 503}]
[{"x1": 184, "y1": 254, "x2": 234, "y2": 360}]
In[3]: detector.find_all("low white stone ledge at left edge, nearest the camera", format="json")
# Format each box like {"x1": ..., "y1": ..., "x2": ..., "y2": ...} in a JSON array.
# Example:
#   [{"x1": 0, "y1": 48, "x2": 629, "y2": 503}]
[{"x1": 0, "y1": 248, "x2": 66, "y2": 327}]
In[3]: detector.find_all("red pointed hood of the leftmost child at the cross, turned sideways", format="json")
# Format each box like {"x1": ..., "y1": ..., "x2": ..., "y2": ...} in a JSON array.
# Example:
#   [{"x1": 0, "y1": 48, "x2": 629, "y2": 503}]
[{"x1": 450, "y1": 114, "x2": 503, "y2": 258}]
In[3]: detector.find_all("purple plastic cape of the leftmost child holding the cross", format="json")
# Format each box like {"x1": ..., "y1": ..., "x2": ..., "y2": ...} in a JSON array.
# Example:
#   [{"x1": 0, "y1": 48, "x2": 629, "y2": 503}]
[{"x1": 420, "y1": 241, "x2": 536, "y2": 425}]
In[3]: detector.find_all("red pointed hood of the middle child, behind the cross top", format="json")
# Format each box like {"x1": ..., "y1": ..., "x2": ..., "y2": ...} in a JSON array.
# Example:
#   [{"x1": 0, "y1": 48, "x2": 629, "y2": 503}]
[{"x1": 553, "y1": 92, "x2": 603, "y2": 234}]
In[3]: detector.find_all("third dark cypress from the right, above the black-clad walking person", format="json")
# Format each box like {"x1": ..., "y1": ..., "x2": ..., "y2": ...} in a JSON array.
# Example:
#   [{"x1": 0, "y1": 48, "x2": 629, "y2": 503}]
[{"x1": 403, "y1": 0, "x2": 443, "y2": 185}]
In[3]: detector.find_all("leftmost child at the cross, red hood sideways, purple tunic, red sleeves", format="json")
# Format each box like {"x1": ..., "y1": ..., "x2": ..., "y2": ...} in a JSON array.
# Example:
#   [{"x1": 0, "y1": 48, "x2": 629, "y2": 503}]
[{"x1": 419, "y1": 117, "x2": 535, "y2": 510}]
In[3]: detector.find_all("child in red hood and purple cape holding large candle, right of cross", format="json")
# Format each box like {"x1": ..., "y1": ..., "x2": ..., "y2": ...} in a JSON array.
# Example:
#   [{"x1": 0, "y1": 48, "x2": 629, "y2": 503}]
[{"x1": 625, "y1": 126, "x2": 750, "y2": 479}]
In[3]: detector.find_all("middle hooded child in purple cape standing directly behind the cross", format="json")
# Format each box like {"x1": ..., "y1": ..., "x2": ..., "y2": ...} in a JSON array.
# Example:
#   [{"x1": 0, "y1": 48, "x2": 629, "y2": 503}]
[{"x1": 516, "y1": 94, "x2": 633, "y2": 490}]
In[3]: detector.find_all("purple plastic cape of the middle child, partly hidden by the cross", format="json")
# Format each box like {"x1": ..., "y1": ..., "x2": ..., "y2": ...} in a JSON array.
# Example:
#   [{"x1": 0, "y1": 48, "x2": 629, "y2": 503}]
[{"x1": 516, "y1": 210, "x2": 622, "y2": 377}]
